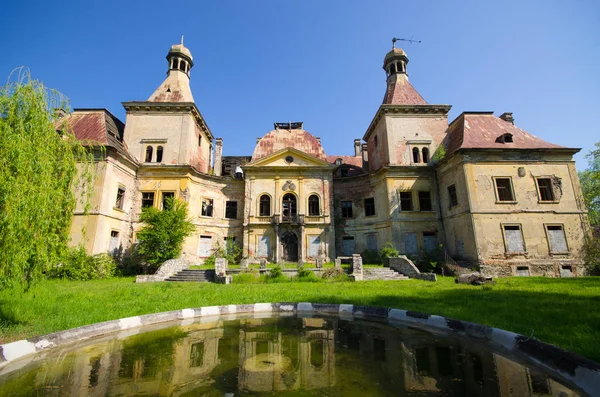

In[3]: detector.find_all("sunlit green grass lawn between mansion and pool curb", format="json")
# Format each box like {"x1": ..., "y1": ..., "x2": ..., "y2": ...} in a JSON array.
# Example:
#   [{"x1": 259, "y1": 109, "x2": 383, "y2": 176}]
[{"x1": 0, "y1": 277, "x2": 600, "y2": 362}]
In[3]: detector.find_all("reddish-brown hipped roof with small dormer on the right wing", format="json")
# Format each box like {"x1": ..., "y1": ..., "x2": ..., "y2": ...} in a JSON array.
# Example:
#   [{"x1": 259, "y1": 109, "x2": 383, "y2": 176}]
[{"x1": 445, "y1": 112, "x2": 565, "y2": 154}]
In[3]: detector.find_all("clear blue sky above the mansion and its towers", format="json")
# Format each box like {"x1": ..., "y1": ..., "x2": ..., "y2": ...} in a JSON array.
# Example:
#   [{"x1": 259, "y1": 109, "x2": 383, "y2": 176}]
[{"x1": 0, "y1": 0, "x2": 600, "y2": 170}]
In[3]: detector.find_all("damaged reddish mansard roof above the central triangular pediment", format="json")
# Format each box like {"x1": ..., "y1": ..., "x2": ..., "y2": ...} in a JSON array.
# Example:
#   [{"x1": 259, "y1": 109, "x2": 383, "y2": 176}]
[{"x1": 252, "y1": 122, "x2": 326, "y2": 161}]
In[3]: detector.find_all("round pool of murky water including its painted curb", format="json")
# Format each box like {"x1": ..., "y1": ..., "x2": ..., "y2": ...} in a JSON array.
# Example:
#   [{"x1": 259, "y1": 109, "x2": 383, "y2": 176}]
[{"x1": 0, "y1": 303, "x2": 600, "y2": 396}]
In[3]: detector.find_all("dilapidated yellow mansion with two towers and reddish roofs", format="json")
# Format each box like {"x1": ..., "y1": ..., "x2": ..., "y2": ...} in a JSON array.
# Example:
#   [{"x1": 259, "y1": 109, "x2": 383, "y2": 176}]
[{"x1": 66, "y1": 40, "x2": 589, "y2": 277}]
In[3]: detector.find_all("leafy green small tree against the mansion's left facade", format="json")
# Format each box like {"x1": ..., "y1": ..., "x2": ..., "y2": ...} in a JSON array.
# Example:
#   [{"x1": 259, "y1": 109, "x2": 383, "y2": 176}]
[{"x1": 137, "y1": 197, "x2": 194, "y2": 267}]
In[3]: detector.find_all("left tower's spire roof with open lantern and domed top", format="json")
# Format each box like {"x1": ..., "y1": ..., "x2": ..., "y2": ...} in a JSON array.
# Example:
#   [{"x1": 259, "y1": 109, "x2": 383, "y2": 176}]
[{"x1": 148, "y1": 36, "x2": 194, "y2": 102}]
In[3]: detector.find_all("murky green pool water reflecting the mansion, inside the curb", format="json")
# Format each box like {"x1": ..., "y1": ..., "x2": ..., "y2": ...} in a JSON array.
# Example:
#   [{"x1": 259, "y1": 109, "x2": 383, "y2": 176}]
[{"x1": 0, "y1": 316, "x2": 580, "y2": 397}]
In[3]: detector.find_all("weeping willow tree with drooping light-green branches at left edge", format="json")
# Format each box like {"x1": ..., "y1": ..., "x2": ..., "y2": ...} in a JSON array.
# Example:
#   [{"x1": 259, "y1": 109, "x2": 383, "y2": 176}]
[{"x1": 0, "y1": 70, "x2": 93, "y2": 289}]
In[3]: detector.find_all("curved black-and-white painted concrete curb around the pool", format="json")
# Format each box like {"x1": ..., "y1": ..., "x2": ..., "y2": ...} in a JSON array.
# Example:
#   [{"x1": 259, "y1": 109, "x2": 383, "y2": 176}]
[{"x1": 0, "y1": 302, "x2": 600, "y2": 394}]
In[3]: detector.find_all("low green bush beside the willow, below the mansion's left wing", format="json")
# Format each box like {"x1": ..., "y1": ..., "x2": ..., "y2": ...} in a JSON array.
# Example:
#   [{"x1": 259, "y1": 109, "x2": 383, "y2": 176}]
[{"x1": 48, "y1": 246, "x2": 117, "y2": 280}]
